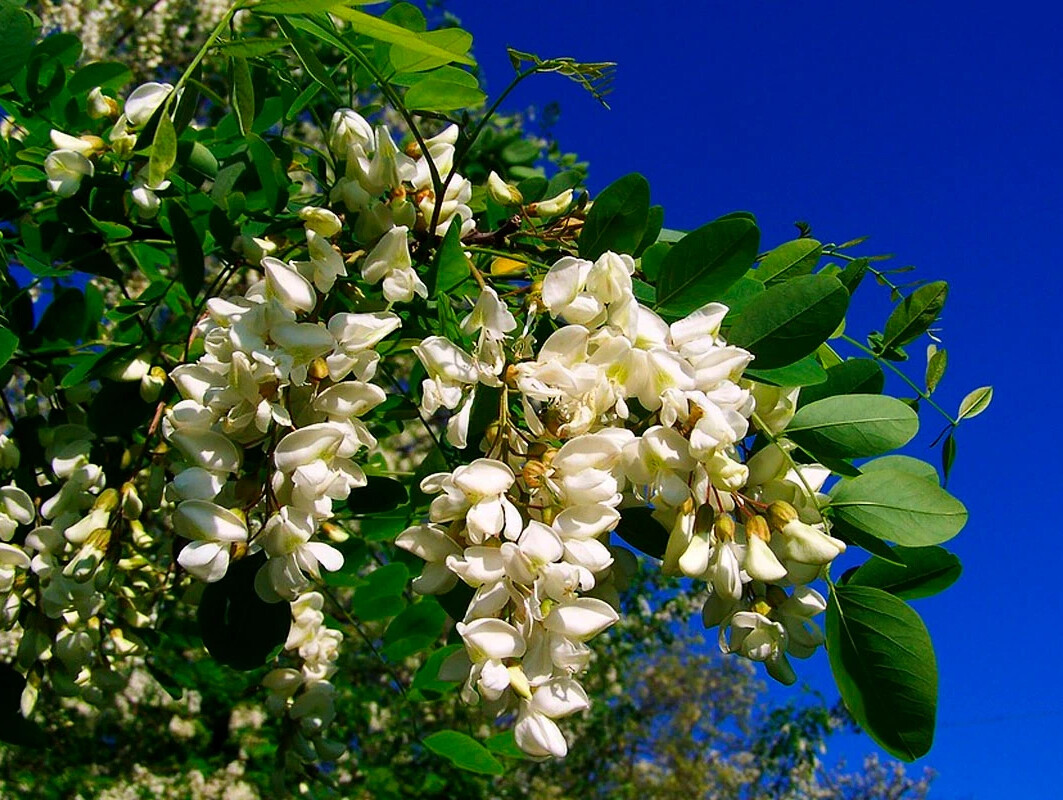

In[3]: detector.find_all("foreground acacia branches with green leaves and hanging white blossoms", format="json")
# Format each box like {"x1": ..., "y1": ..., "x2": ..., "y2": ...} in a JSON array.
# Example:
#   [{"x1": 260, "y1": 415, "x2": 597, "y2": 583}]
[{"x1": 0, "y1": 0, "x2": 991, "y2": 785}]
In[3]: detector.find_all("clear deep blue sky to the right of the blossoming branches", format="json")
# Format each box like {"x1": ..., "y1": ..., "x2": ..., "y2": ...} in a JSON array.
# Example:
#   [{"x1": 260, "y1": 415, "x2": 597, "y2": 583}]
[{"x1": 446, "y1": 0, "x2": 1063, "y2": 800}]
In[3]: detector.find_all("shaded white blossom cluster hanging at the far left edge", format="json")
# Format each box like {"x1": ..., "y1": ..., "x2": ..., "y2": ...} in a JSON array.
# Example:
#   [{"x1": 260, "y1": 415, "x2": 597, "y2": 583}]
[{"x1": 0, "y1": 431, "x2": 147, "y2": 715}]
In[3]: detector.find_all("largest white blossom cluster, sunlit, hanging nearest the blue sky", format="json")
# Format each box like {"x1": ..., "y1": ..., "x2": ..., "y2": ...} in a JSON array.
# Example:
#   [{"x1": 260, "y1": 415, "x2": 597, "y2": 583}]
[{"x1": 398, "y1": 253, "x2": 844, "y2": 758}]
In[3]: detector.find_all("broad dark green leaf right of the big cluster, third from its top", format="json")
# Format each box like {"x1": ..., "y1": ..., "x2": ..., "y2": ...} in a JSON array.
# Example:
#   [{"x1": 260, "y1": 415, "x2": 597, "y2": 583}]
[{"x1": 731, "y1": 271, "x2": 849, "y2": 370}]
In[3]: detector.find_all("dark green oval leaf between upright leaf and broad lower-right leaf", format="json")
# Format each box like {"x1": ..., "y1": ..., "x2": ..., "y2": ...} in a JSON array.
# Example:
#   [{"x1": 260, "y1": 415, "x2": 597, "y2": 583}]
[{"x1": 657, "y1": 217, "x2": 761, "y2": 320}]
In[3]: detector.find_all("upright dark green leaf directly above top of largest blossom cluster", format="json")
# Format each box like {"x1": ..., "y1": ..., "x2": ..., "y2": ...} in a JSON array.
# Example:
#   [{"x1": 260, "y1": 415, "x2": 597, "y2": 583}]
[{"x1": 579, "y1": 172, "x2": 649, "y2": 261}]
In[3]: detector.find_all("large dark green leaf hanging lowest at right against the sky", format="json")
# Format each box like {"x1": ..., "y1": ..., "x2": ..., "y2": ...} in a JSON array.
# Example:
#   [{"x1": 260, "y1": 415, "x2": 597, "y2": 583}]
[{"x1": 827, "y1": 585, "x2": 938, "y2": 761}]
